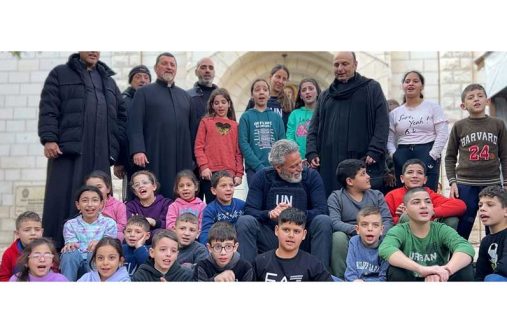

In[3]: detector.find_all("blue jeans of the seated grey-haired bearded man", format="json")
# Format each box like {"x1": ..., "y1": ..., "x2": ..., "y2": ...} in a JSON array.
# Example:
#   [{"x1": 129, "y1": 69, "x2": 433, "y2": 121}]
[{"x1": 236, "y1": 215, "x2": 332, "y2": 268}]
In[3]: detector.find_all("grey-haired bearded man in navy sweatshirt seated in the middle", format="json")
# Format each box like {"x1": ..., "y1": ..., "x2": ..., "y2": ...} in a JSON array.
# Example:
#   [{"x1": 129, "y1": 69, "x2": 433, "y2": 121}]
[{"x1": 236, "y1": 139, "x2": 331, "y2": 268}]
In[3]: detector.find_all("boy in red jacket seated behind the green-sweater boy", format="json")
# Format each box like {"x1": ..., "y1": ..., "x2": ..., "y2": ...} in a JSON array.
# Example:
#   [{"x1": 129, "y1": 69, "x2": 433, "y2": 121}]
[{"x1": 386, "y1": 158, "x2": 466, "y2": 230}]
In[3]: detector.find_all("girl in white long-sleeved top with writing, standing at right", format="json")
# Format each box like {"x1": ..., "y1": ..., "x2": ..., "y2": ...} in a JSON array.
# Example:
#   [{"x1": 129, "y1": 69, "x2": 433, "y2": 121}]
[{"x1": 387, "y1": 71, "x2": 449, "y2": 192}]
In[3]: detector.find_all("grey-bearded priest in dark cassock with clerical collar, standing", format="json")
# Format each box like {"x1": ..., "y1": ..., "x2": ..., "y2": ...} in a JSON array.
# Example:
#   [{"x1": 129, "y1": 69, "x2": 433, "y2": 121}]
[{"x1": 127, "y1": 52, "x2": 196, "y2": 199}]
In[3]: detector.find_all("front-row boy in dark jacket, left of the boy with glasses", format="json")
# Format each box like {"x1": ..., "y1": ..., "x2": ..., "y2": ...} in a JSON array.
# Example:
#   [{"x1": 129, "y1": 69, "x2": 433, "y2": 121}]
[{"x1": 132, "y1": 229, "x2": 192, "y2": 282}]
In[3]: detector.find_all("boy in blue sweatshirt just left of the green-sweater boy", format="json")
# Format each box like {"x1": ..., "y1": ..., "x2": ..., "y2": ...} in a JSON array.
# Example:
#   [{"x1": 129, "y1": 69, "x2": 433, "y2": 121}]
[{"x1": 345, "y1": 206, "x2": 389, "y2": 282}]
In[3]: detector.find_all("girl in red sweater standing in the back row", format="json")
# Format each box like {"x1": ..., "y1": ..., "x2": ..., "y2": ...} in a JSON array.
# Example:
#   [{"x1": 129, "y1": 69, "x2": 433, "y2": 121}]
[{"x1": 194, "y1": 88, "x2": 244, "y2": 204}]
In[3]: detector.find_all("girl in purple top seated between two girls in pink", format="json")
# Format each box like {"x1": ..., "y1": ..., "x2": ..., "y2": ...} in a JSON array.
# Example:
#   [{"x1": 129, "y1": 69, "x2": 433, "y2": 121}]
[{"x1": 126, "y1": 170, "x2": 172, "y2": 245}]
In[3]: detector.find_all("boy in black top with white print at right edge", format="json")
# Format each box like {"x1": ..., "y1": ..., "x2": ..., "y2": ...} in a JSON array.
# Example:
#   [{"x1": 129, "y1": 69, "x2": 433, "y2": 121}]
[{"x1": 475, "y1": 186, "x2": 507, "y2": 282}]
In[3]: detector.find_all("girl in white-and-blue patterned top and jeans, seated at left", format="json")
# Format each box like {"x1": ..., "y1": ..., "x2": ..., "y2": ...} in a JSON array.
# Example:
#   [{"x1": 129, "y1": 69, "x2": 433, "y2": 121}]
[{"x1": 60, "y1": 186, "x2": 118, "y2": 281}]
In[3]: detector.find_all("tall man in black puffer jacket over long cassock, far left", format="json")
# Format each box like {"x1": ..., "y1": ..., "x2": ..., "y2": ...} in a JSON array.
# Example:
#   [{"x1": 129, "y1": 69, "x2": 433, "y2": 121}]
[{"x1": 38, "y1": 51, "x2": 127, "y2": 248}]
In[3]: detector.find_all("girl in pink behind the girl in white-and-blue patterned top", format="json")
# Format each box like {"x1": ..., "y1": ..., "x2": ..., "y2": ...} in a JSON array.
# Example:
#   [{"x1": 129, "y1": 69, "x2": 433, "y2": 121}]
[{"x1": 85, "y1": 170, "x2": 127, "y2": 240}]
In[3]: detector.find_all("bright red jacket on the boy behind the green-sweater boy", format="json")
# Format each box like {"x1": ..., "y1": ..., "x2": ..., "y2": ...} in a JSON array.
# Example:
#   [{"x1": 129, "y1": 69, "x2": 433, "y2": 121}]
[{"x1": 385, "y1": 187, "x2": 467, "y2": 224}]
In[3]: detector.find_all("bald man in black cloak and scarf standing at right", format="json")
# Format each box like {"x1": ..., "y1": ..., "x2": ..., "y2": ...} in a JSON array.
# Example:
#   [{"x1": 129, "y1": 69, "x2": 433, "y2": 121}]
[{"x1": 306, "y1": 52, "x2": 389, "y2": 196}]
